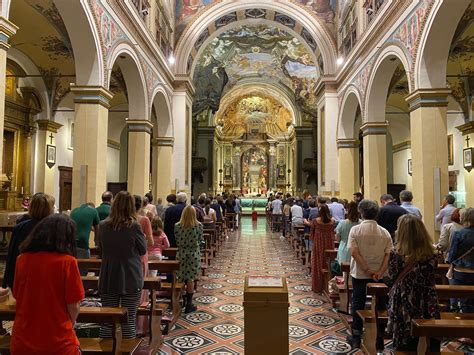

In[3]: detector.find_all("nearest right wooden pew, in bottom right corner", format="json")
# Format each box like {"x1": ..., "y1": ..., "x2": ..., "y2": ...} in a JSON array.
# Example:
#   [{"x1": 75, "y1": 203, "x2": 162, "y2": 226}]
[{"x1": 410, "y1": 319, "x2": 474, "y2": 354}]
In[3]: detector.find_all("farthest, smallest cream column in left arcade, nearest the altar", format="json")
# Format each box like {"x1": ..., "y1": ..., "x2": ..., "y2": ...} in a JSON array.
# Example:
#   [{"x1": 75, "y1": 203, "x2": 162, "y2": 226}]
[{"x1": 151, "y1": 137, "x2": 174, "y2": 201}]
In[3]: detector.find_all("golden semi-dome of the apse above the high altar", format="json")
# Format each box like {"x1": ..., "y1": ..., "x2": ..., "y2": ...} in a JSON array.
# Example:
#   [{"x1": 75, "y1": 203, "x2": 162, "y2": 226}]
[{"x1": 216, "y1": 94, "x2": 293, "y2": 140}]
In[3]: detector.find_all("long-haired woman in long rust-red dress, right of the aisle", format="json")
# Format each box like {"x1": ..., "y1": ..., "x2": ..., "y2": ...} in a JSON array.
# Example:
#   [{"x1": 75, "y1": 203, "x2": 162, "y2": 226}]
[{"x1": 311, "y1": 204, "x2": 335, "y2": 292}]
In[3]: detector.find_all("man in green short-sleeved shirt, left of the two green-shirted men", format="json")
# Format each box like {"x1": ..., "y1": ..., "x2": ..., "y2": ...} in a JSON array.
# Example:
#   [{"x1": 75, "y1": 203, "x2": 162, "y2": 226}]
[{"x1": 70, "y1": 203, "x2": 100, "y2": 259}]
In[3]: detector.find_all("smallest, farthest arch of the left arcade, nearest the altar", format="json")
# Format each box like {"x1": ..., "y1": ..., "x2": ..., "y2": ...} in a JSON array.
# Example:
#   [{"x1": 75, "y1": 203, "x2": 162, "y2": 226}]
[{"x1": 150, "y1": 86, "x2": 174, "y2": 137}]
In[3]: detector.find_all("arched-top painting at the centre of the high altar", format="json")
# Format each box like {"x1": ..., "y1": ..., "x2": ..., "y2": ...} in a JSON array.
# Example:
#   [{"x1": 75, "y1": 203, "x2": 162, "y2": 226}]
[{"x1": 242, "y1": 147, "x2": 268, "y2": 194}]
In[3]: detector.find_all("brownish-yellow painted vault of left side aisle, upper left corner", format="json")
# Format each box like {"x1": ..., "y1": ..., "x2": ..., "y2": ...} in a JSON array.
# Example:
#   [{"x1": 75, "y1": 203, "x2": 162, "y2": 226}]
[{"x1": 10, "y1": 0, "x2": 75, "y2": 110}]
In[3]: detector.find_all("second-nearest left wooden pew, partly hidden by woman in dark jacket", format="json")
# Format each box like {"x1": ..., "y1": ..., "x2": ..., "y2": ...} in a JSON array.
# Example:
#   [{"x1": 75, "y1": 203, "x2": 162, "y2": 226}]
[{"x1": 81, "y1": 276, "x2": 163, "y2": 350}]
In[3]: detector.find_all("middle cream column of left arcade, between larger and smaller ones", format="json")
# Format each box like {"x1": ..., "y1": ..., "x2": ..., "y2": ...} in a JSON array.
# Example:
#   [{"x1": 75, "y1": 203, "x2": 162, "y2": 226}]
[{"x1": 127, "y1": 120, "x2": 153, "y2": 196}]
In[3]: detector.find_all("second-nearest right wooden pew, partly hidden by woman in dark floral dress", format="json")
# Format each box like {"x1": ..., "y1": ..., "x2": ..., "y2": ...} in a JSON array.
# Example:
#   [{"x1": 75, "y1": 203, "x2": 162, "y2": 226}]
[{"x1": 357, "y1": 283, "x2": 474, "y2": 354}]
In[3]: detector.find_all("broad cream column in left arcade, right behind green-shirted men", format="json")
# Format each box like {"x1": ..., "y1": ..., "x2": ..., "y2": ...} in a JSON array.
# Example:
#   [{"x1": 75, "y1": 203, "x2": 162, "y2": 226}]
[{"x1": 71, "y1": 85, "x2": 113, "y2": 208}]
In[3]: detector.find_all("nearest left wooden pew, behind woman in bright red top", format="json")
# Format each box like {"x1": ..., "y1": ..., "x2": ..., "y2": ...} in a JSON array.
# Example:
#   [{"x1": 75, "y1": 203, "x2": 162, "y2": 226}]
[{"x1": 0, "y1": 304, "x2": 142, "y2": 355}]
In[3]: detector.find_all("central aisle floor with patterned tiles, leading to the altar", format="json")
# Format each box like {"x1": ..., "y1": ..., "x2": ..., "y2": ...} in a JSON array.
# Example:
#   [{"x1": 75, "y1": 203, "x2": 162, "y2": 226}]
[{"x1": 160, "y1": 217, "x2": 355, "y2": 354}]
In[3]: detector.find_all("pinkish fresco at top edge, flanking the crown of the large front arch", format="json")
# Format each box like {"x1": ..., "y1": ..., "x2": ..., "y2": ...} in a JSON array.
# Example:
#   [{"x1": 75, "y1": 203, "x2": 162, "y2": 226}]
[{"x1": 175, "y1": 0, "x2": 337, "y2": 42}]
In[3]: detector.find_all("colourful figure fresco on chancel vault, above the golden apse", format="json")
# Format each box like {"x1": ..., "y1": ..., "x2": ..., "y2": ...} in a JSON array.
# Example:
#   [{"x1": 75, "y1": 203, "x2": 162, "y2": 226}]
[{"x1": 193, "y1": 24, "x2": 320, "y2": 119}]
